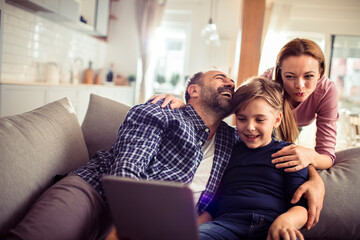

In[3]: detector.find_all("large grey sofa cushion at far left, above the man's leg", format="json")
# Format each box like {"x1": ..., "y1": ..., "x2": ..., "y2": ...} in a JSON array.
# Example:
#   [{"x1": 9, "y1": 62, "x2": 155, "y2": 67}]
[{"x1": 0, "y1": 98, "x2": 89, "y2": 236}]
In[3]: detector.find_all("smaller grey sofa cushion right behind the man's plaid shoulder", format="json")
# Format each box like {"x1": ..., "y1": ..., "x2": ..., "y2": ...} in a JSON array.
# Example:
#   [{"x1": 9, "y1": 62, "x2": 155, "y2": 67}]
[{"x1": 81, "y1": 94, "x2": 130, "y2": 158}]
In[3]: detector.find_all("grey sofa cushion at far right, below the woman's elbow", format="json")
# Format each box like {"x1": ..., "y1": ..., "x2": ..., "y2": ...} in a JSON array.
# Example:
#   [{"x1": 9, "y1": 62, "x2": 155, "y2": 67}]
[{"x1": 304, "y1": 147, "x2": 360, "y2": 239}]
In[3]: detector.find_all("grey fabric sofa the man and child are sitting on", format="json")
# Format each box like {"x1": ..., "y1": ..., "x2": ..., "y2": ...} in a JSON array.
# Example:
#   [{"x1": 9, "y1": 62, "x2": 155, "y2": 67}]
[{"x1": 0, "y1": 94, "x2": 360, "y2": 239}]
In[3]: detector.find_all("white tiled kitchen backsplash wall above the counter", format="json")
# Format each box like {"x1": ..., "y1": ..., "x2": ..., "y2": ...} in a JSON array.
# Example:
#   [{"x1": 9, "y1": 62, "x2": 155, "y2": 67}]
[{"x1": 1, "y1": 2, "x2": 106, "y2": 82}]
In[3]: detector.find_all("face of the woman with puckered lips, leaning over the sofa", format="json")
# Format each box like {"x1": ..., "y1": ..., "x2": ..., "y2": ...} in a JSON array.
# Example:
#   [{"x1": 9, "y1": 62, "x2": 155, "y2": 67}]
[{"x1": 281, "y1": 55, "x2": 320, "y2": 107}]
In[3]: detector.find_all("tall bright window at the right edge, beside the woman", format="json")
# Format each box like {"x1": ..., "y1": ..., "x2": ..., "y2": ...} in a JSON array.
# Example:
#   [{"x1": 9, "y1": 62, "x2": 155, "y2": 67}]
[{"x1": 330, "y1": 35, "x2": 360, "y2": 147}]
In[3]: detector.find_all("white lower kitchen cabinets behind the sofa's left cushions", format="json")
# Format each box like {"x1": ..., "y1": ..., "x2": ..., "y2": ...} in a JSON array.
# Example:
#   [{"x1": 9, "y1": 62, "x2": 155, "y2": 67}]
[{"x1": 0, "y1": 83, "x2": 134, "y2": 124}]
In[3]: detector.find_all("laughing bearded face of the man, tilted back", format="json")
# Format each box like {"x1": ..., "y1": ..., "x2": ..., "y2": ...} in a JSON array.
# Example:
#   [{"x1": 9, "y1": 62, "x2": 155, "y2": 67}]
[{"x1": 201, "y1": 71, "x2": 235, "y2": 117}]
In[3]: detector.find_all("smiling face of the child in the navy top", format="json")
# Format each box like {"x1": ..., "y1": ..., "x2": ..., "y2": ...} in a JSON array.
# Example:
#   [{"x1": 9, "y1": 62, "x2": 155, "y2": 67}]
[{"x1": 236, "y1": 97, "x2": 281, "y2": 148}]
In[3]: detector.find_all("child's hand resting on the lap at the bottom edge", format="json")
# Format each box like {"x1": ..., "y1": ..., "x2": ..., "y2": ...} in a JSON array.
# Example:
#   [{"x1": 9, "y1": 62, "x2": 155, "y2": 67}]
[{"x1": 266, "y1": 215, "x2": 304, "y2": 240}]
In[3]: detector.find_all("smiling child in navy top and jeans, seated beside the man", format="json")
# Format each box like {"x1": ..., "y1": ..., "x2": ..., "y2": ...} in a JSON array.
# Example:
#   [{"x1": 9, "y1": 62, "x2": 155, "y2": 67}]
[{"x1": 199, "y1": 78, "x2": 308, "y2": 240}]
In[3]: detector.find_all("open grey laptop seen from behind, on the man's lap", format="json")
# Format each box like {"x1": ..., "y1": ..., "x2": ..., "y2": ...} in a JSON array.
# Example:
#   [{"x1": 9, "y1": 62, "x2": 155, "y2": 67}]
[{"x1": 103, "y1": 176, "x2": 198, "y2": 240}]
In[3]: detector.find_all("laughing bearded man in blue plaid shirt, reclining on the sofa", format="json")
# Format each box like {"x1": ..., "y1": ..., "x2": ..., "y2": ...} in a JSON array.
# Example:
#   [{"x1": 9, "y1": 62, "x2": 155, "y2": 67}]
[{"x1": 4, "y1": 71, "x2": 323, "y2": 239}]
